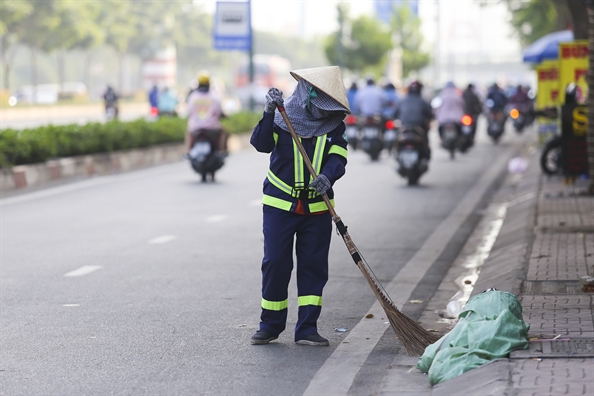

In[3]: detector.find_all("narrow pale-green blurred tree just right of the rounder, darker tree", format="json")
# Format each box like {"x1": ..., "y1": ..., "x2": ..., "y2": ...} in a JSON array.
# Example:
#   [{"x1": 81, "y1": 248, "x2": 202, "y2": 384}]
[{"x1": 391, "y1": 4, "x2": 430, "y2": 77}]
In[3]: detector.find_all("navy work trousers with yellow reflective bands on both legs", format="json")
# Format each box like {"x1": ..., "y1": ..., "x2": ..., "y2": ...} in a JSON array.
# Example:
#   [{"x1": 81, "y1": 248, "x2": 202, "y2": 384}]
[{"x1": 260, "y1": 205, "x2": 332, "y2": 341}]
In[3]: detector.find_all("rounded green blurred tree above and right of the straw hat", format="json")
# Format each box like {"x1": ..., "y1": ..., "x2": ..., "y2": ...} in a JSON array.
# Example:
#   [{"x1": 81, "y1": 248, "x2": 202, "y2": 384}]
[{"x1": 324, "y1": 6, "x2": 392, "y2": 76}]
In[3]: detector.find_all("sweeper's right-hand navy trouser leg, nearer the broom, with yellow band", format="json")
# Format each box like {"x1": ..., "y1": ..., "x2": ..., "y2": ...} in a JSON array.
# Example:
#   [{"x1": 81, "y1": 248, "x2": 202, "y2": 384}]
[{"x1": 295, "y1": 213, "x2": 332, "y2": 341}]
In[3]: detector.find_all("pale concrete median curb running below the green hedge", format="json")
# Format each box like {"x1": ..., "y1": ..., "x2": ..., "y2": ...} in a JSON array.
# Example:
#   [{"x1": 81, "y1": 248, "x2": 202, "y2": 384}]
[{"x1": 0, "y1": 133, "x2": 250, "y2": 194}]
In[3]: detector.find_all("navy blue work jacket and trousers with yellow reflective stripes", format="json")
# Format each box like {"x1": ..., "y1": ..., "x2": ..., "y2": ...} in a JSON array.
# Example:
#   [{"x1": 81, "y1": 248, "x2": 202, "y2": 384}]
[{"x1": 250, "y1": 112, "x2": 347, "y2": 341}]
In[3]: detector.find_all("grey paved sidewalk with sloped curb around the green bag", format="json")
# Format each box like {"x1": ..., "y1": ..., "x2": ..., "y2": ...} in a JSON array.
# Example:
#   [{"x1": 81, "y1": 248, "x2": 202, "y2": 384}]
[{"x1": 382, "y1": 146, "x2": 594, "y2": 396}]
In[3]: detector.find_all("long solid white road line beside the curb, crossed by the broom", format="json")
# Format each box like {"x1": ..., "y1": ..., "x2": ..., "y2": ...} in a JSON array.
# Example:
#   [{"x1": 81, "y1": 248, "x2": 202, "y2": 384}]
[{"x1": 304, "y1": 146, "x2": 513, "y2": 395}]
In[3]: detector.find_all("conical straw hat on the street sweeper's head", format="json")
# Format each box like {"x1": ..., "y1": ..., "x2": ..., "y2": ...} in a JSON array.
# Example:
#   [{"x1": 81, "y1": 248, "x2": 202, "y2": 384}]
[{"x1": 290, "y1": 66, "x2": 351, "y2": 114}]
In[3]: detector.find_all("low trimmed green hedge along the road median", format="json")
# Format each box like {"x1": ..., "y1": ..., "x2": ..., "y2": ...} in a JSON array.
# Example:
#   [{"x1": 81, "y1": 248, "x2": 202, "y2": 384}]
[{"x1": 0, "y1": 112, "x2": 260, "y2": 167}]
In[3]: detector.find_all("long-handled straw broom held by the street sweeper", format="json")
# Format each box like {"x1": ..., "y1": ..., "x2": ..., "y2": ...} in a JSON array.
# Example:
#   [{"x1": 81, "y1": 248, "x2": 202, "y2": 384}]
[{"x1": 277, "y1": 106, "x2": 439, "y2": 356}]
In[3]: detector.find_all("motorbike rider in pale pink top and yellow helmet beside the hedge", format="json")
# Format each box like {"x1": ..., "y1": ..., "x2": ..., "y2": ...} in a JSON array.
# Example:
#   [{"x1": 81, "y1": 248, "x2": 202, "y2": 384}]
[{"x1": 185, "y1": 71, "x2": 228, "y2": 157}]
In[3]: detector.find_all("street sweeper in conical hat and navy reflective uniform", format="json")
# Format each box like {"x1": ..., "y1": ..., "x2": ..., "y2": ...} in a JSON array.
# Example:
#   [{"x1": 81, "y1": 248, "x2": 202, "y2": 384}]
[{"x1": 250, "y1": 66, "x2": 350, "y2": 346}]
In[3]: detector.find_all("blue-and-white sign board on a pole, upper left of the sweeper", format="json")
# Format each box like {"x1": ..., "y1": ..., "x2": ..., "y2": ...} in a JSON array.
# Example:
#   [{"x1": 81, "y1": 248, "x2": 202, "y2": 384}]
[{"x1": 213, "y1": 1, "x2": 252, "y2": 51}]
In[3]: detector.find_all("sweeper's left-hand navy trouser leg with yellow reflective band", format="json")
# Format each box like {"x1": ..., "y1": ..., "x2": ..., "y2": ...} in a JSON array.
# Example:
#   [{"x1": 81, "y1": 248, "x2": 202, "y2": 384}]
[{"x1": 260, "y1": 205, "x2": 301, "y2": 335}]
